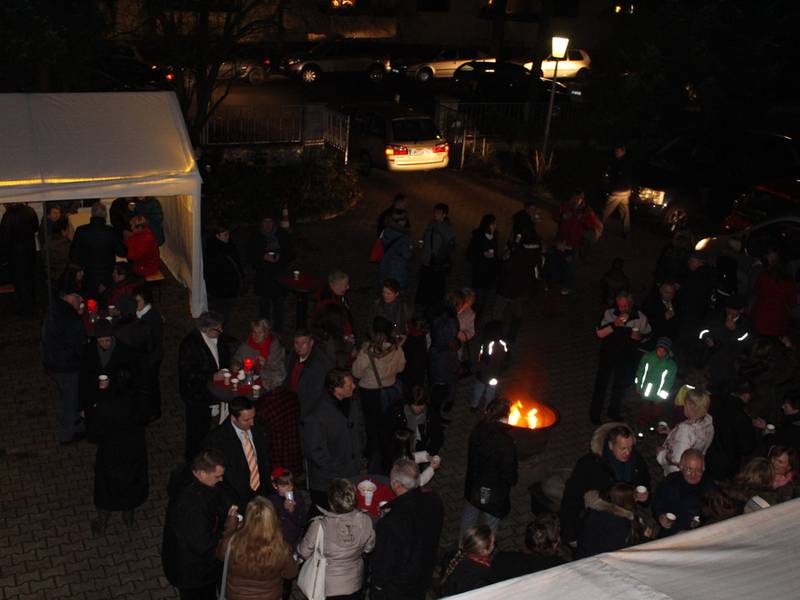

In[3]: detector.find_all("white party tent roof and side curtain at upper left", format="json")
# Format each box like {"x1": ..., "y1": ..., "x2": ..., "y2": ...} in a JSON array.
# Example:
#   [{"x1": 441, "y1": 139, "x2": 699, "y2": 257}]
[{"x1": 0, "y1": 92, "x2": 206, "y2": 316}]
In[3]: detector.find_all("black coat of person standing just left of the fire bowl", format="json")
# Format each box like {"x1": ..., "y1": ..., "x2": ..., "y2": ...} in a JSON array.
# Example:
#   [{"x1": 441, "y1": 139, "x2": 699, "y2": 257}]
[{"x1": 464, "y1": 421, "x2": 519, "y2": 519}]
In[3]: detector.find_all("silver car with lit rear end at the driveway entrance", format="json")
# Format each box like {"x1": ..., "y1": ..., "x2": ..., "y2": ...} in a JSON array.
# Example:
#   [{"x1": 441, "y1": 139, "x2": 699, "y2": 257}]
[{"x1": 345, "y1": 102, "x2": 450, "y2": 174}]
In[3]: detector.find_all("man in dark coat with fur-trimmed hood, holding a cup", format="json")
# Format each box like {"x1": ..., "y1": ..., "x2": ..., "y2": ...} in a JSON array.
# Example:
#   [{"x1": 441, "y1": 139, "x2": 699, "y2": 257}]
[{"x1": 559, "y1": 422, "x2": 650, "y2": 543}]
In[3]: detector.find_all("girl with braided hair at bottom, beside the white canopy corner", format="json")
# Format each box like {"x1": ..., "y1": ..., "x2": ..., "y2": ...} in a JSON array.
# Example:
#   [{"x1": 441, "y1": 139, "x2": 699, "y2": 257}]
[{"x1": 440, "y1": 525, "x2": 495, "y2": 596}]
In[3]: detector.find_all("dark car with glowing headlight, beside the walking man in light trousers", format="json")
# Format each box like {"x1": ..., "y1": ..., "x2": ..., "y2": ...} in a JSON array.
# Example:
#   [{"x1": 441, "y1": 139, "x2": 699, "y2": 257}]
[{"x1": 631, "y1": 127, "x2": 800, "y2": 232}]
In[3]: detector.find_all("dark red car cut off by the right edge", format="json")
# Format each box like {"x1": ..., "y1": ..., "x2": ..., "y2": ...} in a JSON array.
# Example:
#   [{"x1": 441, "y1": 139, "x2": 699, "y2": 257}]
[{"x1": 722, "y1": 177, "x2": 800, "y2": 232}]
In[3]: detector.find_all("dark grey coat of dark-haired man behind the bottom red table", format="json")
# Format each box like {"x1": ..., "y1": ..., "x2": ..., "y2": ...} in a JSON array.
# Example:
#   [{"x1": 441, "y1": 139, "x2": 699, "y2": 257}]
[{"x1": 300, "y1": 394, "x2": 366, "y2": 491}]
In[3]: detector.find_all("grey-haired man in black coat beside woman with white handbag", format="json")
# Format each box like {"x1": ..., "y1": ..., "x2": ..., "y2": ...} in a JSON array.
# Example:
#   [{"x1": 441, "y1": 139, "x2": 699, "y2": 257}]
[{"x1": 370, "y1": 458, "x2": 444, "y2": 600}]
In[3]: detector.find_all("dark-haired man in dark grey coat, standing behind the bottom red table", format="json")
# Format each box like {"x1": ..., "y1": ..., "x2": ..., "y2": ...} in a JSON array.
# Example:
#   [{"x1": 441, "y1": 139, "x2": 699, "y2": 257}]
[{"x1": 300, "y1": 369, "x2": 366, "y2": 508}]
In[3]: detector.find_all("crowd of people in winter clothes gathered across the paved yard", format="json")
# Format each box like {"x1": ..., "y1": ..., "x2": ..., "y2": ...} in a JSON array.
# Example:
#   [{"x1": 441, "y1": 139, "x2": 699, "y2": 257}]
[{"x1": 15, "y1": 163, "x2": 800, "y2": 600}]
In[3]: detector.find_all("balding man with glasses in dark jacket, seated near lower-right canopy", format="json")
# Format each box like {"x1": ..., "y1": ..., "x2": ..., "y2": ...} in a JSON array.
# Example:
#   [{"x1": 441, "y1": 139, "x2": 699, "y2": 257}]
[{"x1": 653, "y1": 448, "x2": 715, "y2": 537}]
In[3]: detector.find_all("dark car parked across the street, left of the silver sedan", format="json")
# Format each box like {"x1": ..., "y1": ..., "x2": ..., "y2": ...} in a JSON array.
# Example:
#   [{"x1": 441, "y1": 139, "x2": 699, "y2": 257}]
[{"x1": 281, "y1": 38, "x2": 391, "y2": 83}]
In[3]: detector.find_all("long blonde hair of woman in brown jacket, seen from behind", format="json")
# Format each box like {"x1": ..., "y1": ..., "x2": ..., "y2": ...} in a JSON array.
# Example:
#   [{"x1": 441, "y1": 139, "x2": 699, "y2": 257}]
[{"x1": 230, "y1": 496, "x2": 291, "y2": 570}]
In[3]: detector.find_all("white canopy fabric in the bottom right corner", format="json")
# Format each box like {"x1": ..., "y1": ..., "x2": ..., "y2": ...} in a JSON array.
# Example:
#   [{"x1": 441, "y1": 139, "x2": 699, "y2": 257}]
[{"x1": 451, "y1": 499, "x2": 800, "y2": 600}]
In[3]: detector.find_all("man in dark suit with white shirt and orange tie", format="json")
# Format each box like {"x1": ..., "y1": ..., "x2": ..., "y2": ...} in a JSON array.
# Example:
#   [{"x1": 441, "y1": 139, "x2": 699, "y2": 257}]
[{"x1": 206, "y1": 396, "x2": 272, "y2": 514}]
